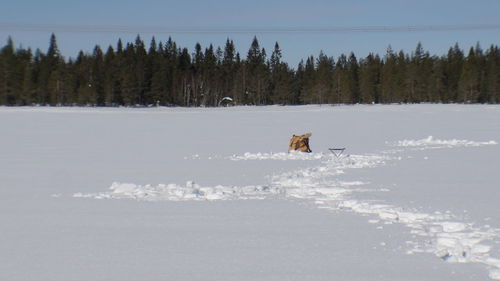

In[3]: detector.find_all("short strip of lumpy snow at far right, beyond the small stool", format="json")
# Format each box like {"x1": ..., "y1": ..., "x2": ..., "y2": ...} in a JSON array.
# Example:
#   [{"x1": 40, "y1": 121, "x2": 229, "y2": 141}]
[{"x1": 396, "y1": 136, "x2": 498, "y2": 148}]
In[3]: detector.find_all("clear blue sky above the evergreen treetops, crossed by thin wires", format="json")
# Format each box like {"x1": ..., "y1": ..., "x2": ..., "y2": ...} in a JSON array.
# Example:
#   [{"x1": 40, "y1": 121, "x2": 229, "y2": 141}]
[{"x1": 0, "y1": 0, "x2": 500, "y2": 67}]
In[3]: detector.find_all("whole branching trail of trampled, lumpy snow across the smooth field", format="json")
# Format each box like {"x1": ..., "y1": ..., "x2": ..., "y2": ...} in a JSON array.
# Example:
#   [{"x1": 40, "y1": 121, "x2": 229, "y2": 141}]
[{"x1": 73, "y1": 136, "x2": 500, "y2": 280}]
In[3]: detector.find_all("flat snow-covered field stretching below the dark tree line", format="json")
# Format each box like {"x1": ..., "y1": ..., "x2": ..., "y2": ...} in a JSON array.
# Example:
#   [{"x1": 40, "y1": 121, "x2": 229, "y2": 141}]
[{"x1": 0, "y1": 105, "x2": 500, "y2": 281}]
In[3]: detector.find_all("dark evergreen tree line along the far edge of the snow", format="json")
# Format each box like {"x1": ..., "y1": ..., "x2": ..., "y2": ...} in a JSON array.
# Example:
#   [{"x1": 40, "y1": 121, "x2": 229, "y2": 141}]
[{"x1": 0, "y1": 34, "x2": 500, "y2": 106}]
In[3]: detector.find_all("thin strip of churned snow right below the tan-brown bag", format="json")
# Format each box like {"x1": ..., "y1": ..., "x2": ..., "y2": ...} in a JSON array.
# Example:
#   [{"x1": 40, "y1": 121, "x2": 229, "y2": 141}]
[{"x1": 229, "y1": 151, "x2": 332, "y2": 161}]
